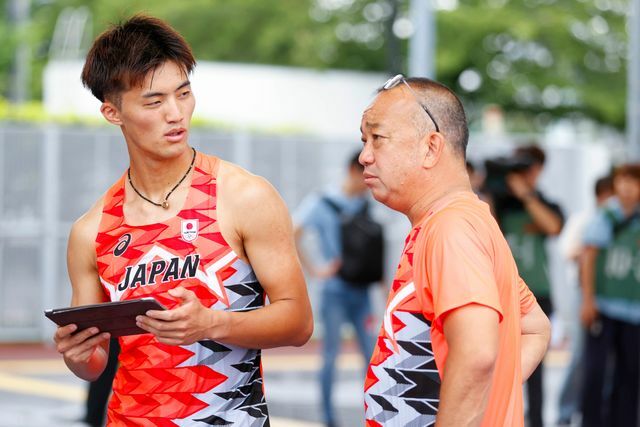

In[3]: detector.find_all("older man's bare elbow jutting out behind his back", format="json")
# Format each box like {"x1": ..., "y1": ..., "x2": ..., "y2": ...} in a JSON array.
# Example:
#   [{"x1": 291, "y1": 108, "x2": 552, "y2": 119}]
[{"x1": 520, "y1": 303, "x2": 551, "y2": 382}]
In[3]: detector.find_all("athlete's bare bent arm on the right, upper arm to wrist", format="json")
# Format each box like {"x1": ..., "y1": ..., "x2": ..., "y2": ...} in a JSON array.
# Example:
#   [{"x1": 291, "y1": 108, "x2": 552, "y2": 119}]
[{"x1": 220, "y1": 178, "x2": 313, "y2": 348}]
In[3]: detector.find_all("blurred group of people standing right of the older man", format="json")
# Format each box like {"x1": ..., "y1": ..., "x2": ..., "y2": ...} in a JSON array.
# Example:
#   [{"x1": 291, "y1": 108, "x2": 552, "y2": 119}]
[{"x1": 467, "y1": 144, "x2": 640, "y2": 427}]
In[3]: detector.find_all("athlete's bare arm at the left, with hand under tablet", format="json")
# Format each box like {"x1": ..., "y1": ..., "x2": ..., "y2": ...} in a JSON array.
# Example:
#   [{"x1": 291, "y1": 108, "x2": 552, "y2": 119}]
[{"x1": 54, "y1": 202, "x2": 109, "y2": 381}]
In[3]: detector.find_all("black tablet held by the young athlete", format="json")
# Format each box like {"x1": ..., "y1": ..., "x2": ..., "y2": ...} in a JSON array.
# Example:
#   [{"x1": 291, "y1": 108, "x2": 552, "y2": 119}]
[{"x1": 44, "y1": 297, "x2": 166, "y2": 338}]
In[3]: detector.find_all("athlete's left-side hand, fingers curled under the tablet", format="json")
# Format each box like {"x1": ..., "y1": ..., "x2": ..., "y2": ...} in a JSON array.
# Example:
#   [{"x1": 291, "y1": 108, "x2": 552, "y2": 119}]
[{"x1": 53, "y1": 324, "x2": 110, "y2": 363}]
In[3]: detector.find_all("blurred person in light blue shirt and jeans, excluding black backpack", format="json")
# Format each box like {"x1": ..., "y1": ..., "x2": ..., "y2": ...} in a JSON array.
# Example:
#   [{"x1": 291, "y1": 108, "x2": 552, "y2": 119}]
[{"x1": 294, "y1": 153, "x2": 384, "y2": 426}]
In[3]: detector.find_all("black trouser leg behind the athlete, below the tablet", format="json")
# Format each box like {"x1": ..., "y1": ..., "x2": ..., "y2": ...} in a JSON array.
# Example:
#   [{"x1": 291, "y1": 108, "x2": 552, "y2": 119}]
[{"x1": 84, "y1": 338, "x2": 120, "y2": 427}]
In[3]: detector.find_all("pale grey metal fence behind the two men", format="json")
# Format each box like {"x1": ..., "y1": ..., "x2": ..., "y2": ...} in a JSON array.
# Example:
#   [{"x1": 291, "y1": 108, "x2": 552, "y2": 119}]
[{"x1": 0, "y1": 125, "x2": 624, "y2": 341}]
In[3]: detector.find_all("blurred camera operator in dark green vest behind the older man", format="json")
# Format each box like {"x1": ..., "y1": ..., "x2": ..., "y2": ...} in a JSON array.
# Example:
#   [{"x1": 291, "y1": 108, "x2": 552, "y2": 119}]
[{"x1": 487, "y1": 145, "x2": 564, "y2": 427}]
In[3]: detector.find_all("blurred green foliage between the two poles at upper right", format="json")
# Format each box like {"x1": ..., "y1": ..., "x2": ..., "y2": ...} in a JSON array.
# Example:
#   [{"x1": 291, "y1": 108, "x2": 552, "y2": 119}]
[{"x1": 437, "y1": 0, "x2": 627, "y2": 127}]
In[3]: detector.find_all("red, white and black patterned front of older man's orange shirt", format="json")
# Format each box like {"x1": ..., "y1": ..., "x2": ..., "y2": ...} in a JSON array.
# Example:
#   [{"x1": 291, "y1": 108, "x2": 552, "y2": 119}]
[{"x1": 364, "y1": 227, "x2": 440, "y2": 427}]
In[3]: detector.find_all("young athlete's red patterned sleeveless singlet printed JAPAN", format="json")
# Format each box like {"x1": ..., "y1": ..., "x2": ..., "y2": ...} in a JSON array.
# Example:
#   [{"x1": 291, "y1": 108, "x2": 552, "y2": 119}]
[{"x1": 96, "y1": 153, "x2": 269, "y2": 426}]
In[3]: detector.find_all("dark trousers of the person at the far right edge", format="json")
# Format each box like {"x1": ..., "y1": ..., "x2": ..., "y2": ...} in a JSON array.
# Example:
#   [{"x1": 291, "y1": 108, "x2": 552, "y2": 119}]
[{"x1": 582, "y1": 315, "x2": 640, "y2": 427}]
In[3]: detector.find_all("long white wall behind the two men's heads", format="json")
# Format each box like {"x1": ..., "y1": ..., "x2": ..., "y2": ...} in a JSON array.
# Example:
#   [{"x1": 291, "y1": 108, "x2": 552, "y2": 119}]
[{"x1": 43, "y1": 61, "x2": 385, "y2": 138}]
